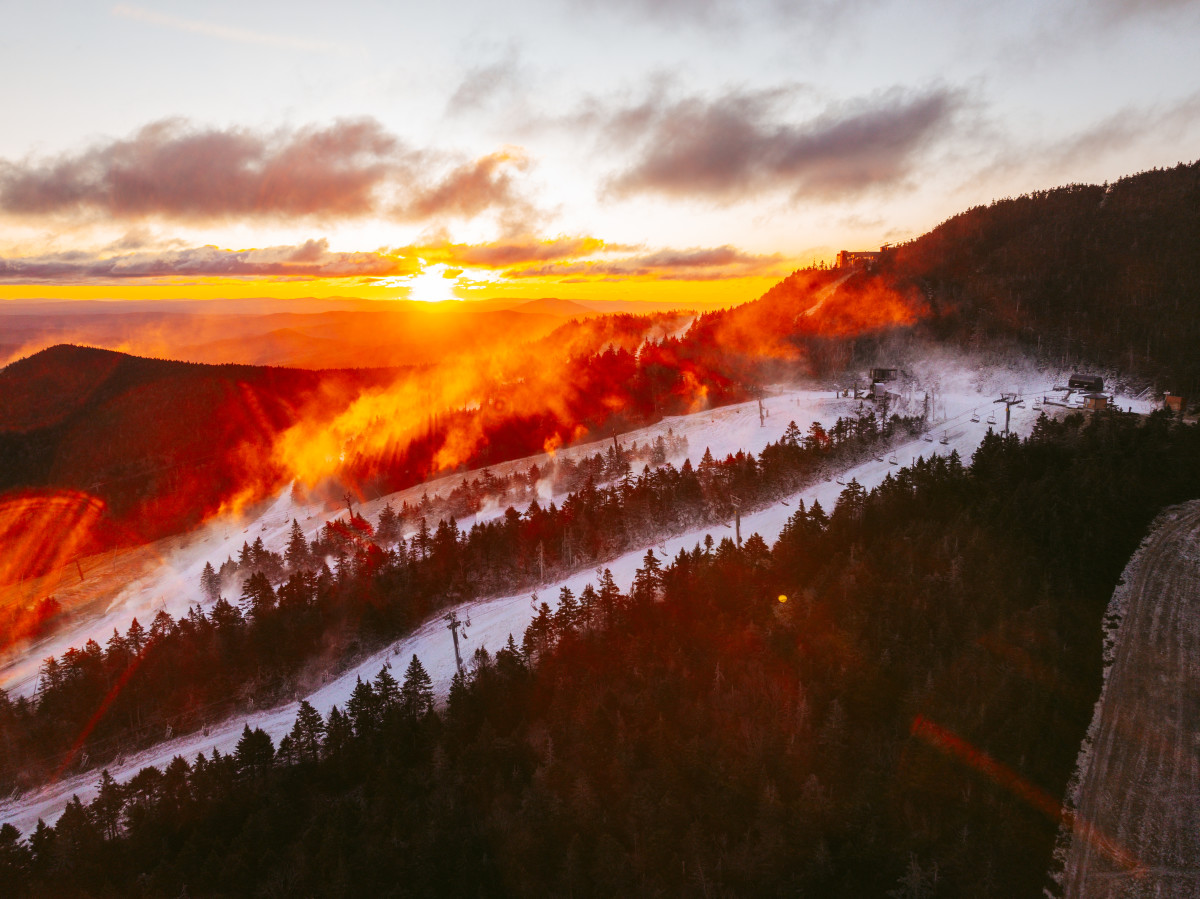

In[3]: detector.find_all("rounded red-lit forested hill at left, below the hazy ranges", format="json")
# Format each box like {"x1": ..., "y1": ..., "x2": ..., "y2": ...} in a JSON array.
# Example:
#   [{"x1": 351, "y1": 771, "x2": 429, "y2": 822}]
[{"x1": 0, "y1": 346, "x2": 397, "y2": 576}]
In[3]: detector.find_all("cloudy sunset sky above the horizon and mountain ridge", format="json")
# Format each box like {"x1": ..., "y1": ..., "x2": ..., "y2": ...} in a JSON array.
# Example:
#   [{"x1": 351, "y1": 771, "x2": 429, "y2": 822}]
[{"x1": 0, "y1": 0, "x2": 1200, "y2": 302}]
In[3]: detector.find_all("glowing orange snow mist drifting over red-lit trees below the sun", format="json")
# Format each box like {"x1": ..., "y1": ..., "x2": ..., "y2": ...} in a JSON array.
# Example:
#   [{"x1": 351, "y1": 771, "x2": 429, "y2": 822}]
[{"x1": 275, "y1": 316, "x2": 703, "y2": 486}]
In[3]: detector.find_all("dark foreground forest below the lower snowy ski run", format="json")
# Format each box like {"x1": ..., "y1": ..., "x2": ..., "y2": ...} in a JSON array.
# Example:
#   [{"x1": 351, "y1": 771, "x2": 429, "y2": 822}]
[{"x1": 0, "y1": 414, "x2": 1200, "y2": 897}]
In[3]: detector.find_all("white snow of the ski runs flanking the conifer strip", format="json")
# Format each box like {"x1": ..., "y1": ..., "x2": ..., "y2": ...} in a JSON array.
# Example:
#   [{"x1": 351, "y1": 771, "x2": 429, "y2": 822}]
[{"x1": 0, "y1": 354, "x2": 1152, "y2": 833}]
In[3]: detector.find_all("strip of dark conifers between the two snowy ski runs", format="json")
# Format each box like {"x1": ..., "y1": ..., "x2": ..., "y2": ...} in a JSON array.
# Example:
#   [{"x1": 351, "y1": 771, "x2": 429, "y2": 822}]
[{"x1": 0, "y1": 405, "x2": 920, "y2": 796}]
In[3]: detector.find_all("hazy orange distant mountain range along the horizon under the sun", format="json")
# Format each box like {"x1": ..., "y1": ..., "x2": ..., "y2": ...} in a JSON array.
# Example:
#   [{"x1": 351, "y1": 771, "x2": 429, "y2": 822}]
[{"x1": 0, "y1": 296, "x2": 734, "y2": 368}]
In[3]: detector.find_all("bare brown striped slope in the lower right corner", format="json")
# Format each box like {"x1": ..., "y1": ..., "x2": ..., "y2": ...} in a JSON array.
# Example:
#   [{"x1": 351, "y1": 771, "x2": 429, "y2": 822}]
[{"x1": 1063, "y1": 501, "x2": 1200, "y2": 899}]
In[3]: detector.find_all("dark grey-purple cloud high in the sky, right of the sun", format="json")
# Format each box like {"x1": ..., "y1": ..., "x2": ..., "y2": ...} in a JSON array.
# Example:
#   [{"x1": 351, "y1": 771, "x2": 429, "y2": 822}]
[{"x1": 601, "y1": 88, "x2": 962, "y2": 202}]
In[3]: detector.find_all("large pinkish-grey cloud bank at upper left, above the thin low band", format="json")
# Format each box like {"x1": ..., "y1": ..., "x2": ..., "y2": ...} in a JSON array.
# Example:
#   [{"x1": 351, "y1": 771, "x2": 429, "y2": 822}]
[{"x1": 0, "y1": 119, "x2": 532, "y2": 221}]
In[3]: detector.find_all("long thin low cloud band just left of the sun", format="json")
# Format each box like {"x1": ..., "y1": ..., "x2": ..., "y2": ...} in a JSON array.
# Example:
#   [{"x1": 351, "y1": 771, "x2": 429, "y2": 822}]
[{"x1": 0, "y1": 240, "x2": 419, "y2": 283}]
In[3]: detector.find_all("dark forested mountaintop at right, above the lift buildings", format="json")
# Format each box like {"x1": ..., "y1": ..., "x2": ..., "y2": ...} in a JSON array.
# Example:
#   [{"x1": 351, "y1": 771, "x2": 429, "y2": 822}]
[{"x1": 878, "y1": 162, "x2": 1200, "y2": 398}]
